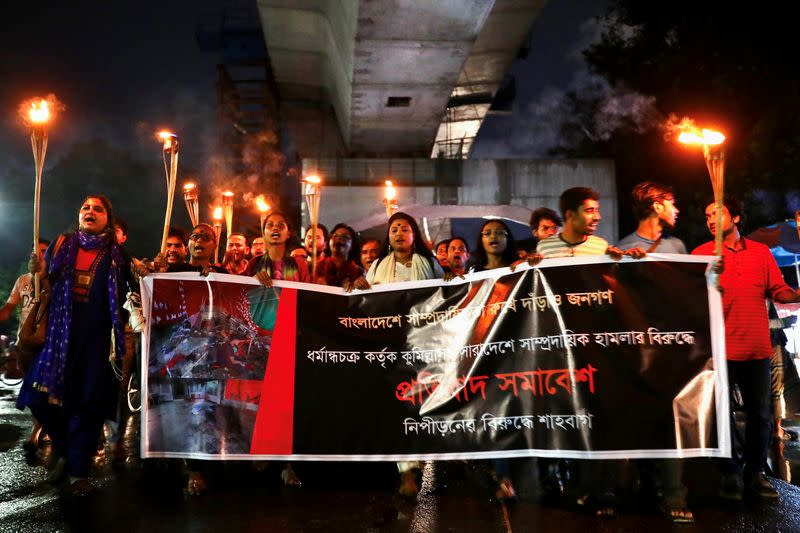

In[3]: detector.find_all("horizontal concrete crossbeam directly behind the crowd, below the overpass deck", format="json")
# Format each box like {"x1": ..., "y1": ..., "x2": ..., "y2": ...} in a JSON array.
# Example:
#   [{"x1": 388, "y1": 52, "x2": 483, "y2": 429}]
[{"x1": 303, "y1": 158, "x2": 619, "y2": 244}]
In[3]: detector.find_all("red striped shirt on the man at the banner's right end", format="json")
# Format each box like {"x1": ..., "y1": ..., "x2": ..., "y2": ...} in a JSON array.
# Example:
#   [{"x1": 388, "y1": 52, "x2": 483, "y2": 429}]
[{"x1": 692, "y1": 238, "x2": 794, "y2": 361}]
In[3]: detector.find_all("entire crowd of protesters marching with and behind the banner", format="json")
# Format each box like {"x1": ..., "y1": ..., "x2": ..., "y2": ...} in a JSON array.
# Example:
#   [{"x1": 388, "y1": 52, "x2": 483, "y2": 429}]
[{"x1": 0, "y1": 182, "x2": 800, "y2": 522}]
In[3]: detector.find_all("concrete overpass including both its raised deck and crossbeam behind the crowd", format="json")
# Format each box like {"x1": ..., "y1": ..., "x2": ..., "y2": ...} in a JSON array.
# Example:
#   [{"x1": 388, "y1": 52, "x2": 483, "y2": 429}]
[{"x1": 257, "y1": 0, "x2": 617, "y2": 241}]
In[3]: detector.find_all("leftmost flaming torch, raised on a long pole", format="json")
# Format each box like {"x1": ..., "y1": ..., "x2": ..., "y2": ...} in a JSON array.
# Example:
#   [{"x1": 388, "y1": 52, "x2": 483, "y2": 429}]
[{"x1": 19, "y1": 95, "x2": 63, "y2": 301}]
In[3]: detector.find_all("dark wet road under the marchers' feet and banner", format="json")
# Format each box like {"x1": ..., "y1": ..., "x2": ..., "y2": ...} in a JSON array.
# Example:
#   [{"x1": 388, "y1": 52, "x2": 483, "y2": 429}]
[{"x1": 0, "y1": 383, "x2": 800, "y2": 533}]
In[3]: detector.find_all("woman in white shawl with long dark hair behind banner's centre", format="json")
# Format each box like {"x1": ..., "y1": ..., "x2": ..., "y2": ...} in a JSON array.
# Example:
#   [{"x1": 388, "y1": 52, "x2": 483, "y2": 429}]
[{"x1": 344, "y1": 212, "x2": 444, "y2": 498}]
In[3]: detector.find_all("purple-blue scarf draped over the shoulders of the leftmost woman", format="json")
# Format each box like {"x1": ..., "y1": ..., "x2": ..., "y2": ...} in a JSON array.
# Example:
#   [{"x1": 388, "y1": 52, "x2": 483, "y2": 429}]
[{"x1": 31, "y1": 230, "x2": 125, "y2": 404}]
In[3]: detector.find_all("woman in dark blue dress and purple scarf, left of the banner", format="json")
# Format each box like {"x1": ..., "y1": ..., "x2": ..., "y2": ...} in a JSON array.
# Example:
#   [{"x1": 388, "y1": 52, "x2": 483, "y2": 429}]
[{"x1": 17, "y1": 195, "x2": 131, "y2": 496}]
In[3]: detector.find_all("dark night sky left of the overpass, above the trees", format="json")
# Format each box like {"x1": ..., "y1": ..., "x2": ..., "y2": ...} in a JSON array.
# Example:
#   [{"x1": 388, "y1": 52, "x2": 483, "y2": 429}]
[{"x1": 0, "y1": 0, "x2": 217, "y2": 164}]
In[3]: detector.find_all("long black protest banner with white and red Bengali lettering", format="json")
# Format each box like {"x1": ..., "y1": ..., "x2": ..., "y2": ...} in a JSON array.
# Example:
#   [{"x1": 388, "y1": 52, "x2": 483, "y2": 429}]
[{"x1": 142, "y1": 254, "x2": 730, "y2": 461}]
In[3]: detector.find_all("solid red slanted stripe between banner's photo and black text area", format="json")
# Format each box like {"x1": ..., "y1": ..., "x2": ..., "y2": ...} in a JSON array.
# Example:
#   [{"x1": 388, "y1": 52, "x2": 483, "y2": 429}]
[{"x1": 250, "y1": 288, "x2": 297, "y2": 455}]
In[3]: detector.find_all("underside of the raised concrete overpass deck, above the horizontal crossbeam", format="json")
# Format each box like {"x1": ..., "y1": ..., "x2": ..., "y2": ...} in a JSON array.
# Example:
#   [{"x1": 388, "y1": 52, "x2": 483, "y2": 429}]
[{"x1": 257, "y1": 0, "x2": 546, "y2": 158}]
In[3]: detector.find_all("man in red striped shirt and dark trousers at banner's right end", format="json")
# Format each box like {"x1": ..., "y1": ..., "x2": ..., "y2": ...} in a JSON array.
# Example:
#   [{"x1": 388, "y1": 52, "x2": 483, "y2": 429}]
[{"x1": 692, "y1": 198, "x2": 800, "y2": 500}]
